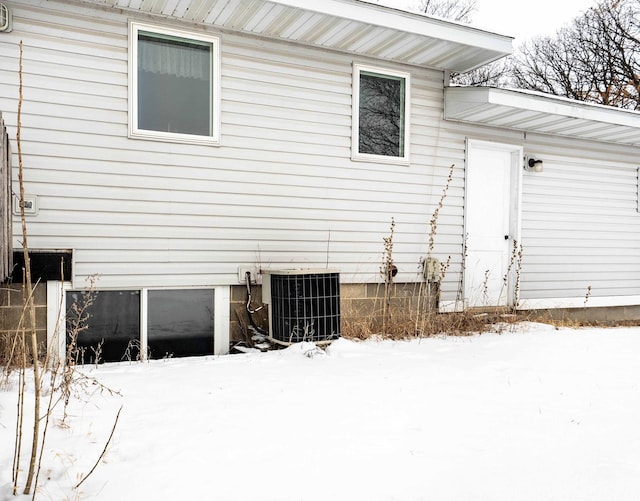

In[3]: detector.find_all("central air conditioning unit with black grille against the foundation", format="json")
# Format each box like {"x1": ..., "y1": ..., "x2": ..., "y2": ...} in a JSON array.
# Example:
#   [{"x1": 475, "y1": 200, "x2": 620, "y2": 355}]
[{"x1": 262, "y1": 269, "x2": 340, "y2": 345}]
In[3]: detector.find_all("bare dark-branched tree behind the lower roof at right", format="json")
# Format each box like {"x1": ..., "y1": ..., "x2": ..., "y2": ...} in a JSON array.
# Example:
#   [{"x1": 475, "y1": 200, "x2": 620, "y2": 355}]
[{"x1": 511, "y1": 0, "x2": 640, "y2": 109}]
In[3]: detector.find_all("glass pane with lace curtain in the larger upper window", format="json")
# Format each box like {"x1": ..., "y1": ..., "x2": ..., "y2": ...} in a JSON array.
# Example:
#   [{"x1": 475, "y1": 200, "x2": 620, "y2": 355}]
[{"x1": 137, "y1": 31, "x2": 213, "y2": 136}]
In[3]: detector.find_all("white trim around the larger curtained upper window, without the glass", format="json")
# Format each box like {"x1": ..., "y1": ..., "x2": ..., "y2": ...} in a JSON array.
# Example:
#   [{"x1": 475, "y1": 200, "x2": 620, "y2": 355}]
[{"x1": 129, "y1": 21, "x2": 222, "y2": 146}]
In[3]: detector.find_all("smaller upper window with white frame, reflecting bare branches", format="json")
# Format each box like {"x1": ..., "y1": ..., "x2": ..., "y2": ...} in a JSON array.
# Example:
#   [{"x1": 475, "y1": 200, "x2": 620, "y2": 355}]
[{"x1": 351, "y1": 64, "x2": 411, "y2": 164}]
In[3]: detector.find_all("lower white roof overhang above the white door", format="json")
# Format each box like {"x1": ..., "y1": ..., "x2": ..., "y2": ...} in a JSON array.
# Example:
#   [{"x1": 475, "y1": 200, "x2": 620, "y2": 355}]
[{"x1": 444, "y1": 87, "x2": 640, "y2": 146}]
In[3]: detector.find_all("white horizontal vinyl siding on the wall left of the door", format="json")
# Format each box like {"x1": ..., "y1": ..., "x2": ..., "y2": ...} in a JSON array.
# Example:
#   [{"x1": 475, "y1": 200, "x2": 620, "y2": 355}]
[{"x1": 5, "y1": 2, "x2": 464, "y2": 290}]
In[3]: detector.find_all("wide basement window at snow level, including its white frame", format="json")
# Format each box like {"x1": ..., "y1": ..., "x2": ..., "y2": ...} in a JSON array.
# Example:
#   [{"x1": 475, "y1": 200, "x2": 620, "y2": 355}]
[{"x1": 58, "y1": 282, "x2": 231, "y2": 364}]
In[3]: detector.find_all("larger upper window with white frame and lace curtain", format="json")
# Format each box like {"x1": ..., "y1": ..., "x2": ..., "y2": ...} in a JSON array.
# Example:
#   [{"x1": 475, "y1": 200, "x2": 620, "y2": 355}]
[{"x1": 129, "y1": 22, "x2": 220, "y2": 145}]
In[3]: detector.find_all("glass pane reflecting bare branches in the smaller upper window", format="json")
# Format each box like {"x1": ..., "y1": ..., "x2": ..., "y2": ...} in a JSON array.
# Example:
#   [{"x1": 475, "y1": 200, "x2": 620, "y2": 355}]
[{"x1": 358, "y1": 72, "x2": 405, "y2": 157}]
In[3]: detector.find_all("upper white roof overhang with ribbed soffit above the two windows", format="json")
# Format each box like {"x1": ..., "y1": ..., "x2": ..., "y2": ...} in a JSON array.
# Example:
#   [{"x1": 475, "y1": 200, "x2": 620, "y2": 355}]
[{"x1": 72, "y1": 0, "x2": 513, "y2": 72}]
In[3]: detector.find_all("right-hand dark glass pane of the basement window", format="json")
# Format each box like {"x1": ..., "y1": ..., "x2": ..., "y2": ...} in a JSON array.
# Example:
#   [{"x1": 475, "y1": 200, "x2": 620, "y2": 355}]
[{"x1": 147, "y1": 289, "x2": 213, "y2": 358}]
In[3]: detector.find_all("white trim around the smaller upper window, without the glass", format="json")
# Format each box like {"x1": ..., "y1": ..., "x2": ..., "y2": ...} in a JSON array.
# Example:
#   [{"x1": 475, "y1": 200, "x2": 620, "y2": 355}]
[{"x1": 351, "y1": 63, "x2": 411, "y2": 165}]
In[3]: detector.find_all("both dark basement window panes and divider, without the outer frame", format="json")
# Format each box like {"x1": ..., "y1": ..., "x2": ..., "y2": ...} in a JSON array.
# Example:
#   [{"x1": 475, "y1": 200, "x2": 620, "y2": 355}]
[{"x1": 66, "y1": 289, "x2": 215, "y2": 364}]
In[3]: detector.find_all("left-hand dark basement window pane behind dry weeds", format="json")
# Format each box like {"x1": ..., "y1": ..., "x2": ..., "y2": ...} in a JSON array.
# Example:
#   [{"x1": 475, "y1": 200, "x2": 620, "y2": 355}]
[{"x1": 66, "y1": 291, "x2": 140, "y2": 363}]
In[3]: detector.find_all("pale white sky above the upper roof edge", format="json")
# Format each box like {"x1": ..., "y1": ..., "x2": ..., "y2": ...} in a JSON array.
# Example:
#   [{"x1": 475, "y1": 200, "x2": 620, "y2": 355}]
[{"x1": 379, "y1": 0, "x2": 596, "y2": 45}]
